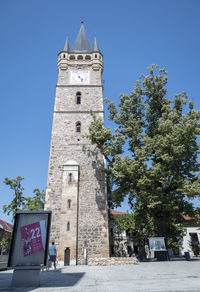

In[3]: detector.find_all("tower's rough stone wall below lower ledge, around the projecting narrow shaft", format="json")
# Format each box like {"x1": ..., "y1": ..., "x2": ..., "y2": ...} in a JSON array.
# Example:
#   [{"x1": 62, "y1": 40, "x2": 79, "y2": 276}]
[{"x1": 46, "y1": 113, "x2": 108, "y2": 263}]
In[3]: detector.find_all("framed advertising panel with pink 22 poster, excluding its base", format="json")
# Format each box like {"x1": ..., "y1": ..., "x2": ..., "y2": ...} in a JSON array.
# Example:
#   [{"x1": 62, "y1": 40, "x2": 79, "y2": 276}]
[{"x1": 8, "y1": 211, "x2": 51, "y2": 268}]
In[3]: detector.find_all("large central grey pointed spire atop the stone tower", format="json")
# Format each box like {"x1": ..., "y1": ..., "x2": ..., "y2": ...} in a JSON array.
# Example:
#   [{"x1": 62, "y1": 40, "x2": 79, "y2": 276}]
[{"x1": 72, "y1": 21, "x2": 91, "y2": 52}]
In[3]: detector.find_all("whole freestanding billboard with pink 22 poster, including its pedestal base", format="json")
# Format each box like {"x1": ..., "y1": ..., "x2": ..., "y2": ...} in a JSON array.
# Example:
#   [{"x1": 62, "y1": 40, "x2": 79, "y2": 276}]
[{"x1": 8, "y1": 211, "x2": 51, "y2": 287}]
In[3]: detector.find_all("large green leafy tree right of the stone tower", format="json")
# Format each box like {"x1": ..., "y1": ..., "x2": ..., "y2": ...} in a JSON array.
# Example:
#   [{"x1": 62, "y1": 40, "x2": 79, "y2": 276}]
[{"x1": 88, "y1": 65, "x2": 200, "y2": 248}]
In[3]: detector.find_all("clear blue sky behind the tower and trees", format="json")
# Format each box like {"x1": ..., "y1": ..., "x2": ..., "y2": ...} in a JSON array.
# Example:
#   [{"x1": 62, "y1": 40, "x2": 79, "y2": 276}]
[{"x1": 0, "y1": 0, "x2": 200, "y2": 222}]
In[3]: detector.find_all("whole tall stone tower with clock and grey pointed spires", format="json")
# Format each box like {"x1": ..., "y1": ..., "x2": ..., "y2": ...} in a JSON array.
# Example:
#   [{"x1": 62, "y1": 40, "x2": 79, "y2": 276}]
[{"x1": 45, "y1": 23, "x2": 109, "y2": 264}]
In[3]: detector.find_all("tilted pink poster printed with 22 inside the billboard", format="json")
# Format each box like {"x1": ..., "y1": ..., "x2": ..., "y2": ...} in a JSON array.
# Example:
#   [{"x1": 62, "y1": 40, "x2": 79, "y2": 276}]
[{"x1": 20, "y1": 221, "x2": 45, "y2": 257}]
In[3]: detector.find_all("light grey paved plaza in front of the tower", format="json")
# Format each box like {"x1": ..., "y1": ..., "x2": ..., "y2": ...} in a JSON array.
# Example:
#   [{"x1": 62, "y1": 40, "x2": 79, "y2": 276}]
[{"x1": 0, "y1": 260, "x2": 200, "y2": 292}]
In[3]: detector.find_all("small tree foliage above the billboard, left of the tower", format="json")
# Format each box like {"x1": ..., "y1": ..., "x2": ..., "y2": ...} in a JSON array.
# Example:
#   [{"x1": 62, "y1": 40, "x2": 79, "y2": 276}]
[{"x1": 3, "y1": 176, "x2": 45, "y2": 219}]
